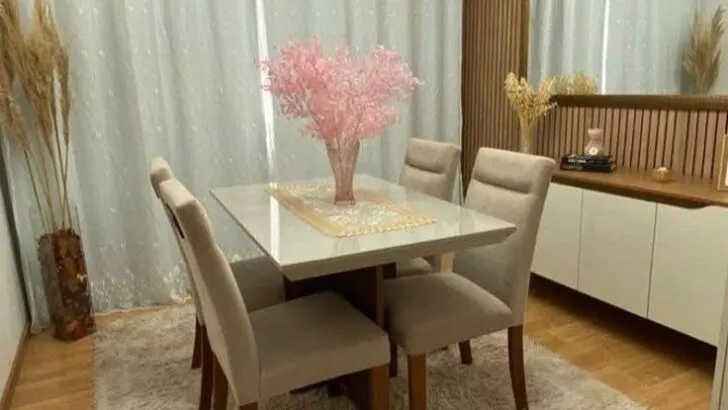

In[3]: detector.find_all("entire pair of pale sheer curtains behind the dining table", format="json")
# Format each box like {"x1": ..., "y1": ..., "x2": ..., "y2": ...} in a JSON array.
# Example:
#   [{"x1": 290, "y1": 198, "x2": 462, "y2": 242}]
[{"x1": 5, "y1": 0, "x2": 462, "y2": 330}]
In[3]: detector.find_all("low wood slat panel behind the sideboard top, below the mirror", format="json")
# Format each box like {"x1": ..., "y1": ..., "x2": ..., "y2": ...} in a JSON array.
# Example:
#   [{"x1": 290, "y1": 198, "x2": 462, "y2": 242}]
[{"x1": 536, "y1": 107, "x2": 728, "y2": 179}]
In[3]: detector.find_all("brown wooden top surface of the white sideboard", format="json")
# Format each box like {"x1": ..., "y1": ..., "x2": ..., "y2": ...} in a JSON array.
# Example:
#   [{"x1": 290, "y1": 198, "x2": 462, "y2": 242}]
[{"x1": 552, "y1": 168, "x2": 728, "y2": 208}]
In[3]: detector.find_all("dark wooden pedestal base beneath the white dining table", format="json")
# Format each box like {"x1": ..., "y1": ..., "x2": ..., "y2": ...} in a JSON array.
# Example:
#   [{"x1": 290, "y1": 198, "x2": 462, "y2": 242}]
[{"x1": 285, "y1": 264, "x2": 396, "y2": 409}]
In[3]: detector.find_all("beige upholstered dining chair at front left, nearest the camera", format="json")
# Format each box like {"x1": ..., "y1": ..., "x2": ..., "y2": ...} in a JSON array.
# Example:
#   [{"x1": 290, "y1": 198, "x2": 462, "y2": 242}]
[{"x1": 160, "y1": 180, "x2": 389, "y2": 410}]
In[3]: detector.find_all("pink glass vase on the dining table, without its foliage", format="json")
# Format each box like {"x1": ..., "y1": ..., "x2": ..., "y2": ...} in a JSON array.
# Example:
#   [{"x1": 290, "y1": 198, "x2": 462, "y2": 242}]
[{"x1": 326, "y1": 138, "x2": 359, "y2": 205}]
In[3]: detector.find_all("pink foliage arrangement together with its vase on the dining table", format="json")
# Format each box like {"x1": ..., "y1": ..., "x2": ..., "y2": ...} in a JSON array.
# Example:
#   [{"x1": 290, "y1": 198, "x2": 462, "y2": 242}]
[{"x1": 260, "y1": 39, "x2": 420, "y2": 205}]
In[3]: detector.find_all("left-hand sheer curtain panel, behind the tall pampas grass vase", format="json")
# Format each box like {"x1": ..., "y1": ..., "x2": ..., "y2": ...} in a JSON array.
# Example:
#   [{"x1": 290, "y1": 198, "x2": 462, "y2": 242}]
[{"x1": 6, "y1": 0, "x2": 268, "y2": 330}]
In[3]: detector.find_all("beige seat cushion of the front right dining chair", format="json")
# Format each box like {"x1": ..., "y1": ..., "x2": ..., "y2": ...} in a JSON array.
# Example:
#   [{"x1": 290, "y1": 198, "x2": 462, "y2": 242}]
[{"x1": 384, "y1": 272, "x2": 512, "y2": 355}]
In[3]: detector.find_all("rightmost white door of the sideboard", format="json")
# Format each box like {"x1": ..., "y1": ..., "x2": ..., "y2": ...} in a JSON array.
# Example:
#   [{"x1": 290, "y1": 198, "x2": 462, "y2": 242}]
[{"x1": 647, "y1": 205, "x2": 728, "y2": 346}]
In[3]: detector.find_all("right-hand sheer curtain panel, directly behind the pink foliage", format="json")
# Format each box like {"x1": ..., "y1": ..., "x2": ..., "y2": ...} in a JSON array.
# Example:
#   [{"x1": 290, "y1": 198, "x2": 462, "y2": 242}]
[{"x1": 261, "y1": 0, "x2": 462, "y2": 188}]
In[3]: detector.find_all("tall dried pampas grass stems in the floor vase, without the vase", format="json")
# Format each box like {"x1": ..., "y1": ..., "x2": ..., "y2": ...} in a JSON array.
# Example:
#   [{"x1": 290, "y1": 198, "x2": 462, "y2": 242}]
[{"x1": 0, "y1": 0, "x2": 72, "y2": 232}]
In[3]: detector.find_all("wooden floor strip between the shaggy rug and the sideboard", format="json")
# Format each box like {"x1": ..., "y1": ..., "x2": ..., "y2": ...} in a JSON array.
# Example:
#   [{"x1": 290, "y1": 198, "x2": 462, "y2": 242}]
[{"x1": 526, "y1": 279, "x2": 716, "y2": 410}]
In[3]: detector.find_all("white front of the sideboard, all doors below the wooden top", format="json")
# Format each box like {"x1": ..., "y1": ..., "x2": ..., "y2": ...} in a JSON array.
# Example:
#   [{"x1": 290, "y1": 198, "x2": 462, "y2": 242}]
[{"x1": 532, "y1": 183, "x2": 728, "y2": 345}]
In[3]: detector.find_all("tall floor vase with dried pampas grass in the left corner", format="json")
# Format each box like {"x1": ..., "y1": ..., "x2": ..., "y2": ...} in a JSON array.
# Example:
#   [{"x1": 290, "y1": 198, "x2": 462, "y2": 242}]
[{"x1": 0, "y1": 0, "x2": 96, "y2": 341}]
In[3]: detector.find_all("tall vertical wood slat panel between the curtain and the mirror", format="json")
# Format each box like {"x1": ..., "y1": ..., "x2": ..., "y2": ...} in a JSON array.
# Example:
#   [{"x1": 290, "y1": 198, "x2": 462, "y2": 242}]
[{"x1": 462, "y1": 0, "x2": 529, "y2": 186}]
